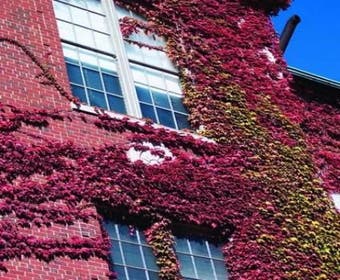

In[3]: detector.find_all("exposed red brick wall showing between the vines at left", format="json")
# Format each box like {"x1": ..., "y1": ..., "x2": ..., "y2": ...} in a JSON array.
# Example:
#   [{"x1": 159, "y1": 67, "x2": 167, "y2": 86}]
[{"x1": 0, "y1": 0, "x2": 117, "y2": 280}]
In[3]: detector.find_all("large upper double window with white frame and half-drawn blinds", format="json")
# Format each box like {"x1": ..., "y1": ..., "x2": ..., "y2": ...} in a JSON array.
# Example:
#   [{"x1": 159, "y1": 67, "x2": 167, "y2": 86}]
[{"x1": 53, "y1": 0, "x2": 189, "y2": 129}]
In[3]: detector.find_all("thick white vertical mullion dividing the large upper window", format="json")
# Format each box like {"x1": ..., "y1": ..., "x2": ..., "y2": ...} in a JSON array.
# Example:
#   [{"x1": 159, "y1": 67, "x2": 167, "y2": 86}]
[{"x1": 103, "y1": 0, "x2": 142, "y2": 118}]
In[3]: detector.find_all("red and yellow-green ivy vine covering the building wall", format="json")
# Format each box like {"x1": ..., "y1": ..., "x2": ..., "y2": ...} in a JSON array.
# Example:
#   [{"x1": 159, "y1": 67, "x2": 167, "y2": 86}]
[{"x1": 0, "y1": 0, "x2": 340, "y2": 280}]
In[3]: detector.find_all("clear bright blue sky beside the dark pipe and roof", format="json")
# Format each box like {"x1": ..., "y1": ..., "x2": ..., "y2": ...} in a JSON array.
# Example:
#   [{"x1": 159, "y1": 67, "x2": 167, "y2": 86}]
[{"x1": 272, "y1": 0, "x2": 340, "y2": 82}]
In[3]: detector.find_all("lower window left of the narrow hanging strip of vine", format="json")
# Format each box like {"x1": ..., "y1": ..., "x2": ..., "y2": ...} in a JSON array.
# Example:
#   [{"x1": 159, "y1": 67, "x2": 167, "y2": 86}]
[{"x1": 104, "y1": 220, "x2": 159, "y2": 280}]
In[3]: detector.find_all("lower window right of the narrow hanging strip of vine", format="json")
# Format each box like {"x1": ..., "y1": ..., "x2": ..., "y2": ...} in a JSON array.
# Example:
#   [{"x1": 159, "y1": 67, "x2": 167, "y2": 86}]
[{"x1": 175, "y1": 238, "x2": 228, "y2": 280}]
